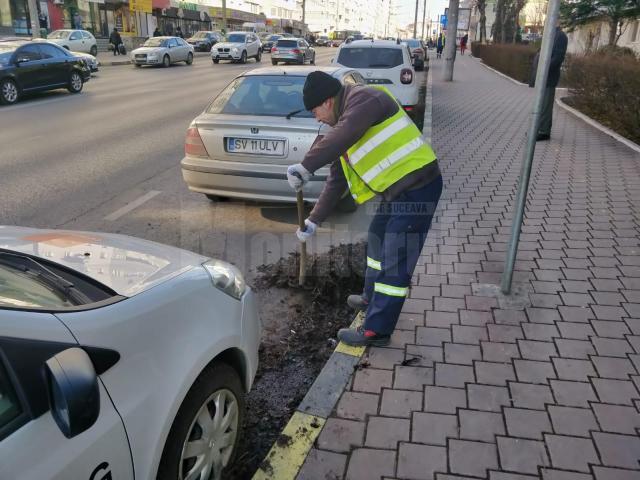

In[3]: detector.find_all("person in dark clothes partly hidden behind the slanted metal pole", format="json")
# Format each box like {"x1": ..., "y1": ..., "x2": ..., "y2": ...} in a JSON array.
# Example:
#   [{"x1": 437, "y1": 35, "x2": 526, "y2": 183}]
[{"x1": 529, "y1": 22, "x2": 569, "y2": 141}]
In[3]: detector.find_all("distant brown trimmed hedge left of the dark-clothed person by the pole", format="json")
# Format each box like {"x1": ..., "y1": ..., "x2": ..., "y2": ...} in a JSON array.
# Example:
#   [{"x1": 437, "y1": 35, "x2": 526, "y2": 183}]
[{"x1": 471, "y1": 42, "x2": 538, "y2": 83}]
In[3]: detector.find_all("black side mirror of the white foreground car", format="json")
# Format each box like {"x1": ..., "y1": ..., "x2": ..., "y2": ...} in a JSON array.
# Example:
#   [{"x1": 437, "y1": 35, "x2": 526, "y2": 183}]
[{"x1": 45, "y1": 347, "x2": 100, "y2": 438}]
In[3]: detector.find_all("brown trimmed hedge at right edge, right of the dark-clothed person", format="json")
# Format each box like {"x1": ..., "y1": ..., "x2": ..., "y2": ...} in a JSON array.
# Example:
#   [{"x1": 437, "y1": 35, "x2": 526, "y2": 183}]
[{"x1": 565, "y1": 52, "x2": 640, "y2": 144}]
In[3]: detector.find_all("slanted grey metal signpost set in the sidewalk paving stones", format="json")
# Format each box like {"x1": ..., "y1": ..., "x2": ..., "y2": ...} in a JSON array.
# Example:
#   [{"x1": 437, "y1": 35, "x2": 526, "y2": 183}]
[{"x1": 500, "y1": 0, "x2": 560, "y2": 295}]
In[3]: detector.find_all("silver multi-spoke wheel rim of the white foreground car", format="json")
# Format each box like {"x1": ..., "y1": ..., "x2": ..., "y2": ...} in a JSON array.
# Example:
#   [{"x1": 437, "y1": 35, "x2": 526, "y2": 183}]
[{"x1": 179, "y1": 389, "x2": 240, "y2": 480}]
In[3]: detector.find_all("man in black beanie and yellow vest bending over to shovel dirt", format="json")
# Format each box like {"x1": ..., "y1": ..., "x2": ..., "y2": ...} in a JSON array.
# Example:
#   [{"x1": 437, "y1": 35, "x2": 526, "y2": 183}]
[{"x1": 287, "y1": 71, "x2": 442, "y2": 346}]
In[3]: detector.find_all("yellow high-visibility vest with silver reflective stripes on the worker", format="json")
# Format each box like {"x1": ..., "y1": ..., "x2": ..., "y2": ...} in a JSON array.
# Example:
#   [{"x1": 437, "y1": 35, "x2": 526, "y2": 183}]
[{"x1": 340, "y1": 86, "x2": 436, "y2": 204}]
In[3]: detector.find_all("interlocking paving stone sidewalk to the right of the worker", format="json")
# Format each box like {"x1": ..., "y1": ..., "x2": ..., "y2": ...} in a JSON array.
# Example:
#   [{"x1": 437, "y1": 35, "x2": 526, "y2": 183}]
[{"x1": 297, "y1": 52, "x2": 640, "y2": 480}]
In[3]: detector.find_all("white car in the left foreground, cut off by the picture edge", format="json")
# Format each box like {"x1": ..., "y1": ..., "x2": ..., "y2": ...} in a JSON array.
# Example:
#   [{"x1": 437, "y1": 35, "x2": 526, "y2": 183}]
[{"x1": 0, "y1": 227, "x2": 260, "y2": 480}]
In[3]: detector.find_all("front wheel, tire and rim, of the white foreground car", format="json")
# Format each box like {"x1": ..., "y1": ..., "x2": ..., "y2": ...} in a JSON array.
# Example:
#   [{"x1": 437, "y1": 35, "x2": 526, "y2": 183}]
[{"x1": 157, "y1": 363, "x2": 245, "y2": 480}]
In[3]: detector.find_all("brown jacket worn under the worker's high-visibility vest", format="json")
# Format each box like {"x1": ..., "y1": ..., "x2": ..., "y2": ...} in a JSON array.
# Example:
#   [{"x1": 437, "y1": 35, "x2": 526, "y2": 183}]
[{"x1": 302, "y1": 85, "x2": 440, "y2": 224}]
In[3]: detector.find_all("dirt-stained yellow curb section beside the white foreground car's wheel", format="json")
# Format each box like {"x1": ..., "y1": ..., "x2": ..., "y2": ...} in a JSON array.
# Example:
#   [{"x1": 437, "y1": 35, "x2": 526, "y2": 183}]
[{"x1": 252, "y1": 412, "x2": 326, "y2": 480}]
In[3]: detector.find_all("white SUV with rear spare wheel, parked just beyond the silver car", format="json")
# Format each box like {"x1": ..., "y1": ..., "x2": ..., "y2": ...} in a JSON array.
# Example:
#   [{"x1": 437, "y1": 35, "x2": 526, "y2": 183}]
[{"x1": 332, "y1": 40, "x2": 419, "y2": 120}]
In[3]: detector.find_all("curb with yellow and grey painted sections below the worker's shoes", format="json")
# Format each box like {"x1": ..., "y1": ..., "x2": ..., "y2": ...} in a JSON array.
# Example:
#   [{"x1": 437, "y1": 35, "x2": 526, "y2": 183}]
[{"x1": 252, "y1": 312, "x2": 366, "y2": 480}]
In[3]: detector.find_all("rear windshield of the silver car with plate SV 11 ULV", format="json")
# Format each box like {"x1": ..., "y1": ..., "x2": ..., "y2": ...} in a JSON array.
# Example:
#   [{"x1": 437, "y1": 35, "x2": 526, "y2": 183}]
[{"x1": 207, "y1": 75, "x2": 313, "y2": 118}]
